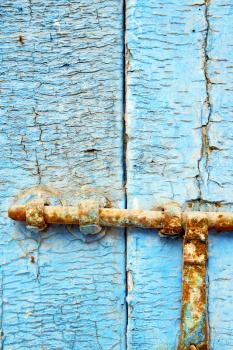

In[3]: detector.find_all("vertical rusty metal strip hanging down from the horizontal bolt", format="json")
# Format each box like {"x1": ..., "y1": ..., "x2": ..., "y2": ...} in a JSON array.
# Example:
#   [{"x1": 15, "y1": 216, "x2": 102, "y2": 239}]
[{"x1": 178, "y1": 216, "x2": 209, "y2": 350}]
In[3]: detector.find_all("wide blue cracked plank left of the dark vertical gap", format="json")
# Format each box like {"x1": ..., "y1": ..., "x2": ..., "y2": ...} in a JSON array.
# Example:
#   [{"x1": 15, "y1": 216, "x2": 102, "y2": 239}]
[{"x1": 0, "y1": 0, "x2": 126, "y2": 350}]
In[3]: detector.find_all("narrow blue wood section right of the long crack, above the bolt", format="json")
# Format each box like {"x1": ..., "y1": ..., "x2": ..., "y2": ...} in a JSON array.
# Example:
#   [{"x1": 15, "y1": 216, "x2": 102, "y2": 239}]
[{"x1": 202, "y1": 0, "x2": 233, "y2": 204}]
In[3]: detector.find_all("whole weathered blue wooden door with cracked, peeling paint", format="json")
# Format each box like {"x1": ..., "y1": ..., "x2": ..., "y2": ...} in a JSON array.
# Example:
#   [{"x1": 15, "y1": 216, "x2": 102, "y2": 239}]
[{"x1": 0, "y1": 0, "x2": 233, "y2": 350}]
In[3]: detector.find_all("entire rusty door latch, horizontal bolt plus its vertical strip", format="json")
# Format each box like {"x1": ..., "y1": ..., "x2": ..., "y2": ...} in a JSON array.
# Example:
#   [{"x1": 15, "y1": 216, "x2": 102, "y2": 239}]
[{"x1": 8, "y1": 200, "x2": 233, "y2": 350}]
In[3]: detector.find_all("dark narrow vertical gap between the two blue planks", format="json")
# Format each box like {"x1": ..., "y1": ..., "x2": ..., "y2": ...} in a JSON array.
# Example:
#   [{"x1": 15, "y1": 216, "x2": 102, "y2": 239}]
[{"x1": 122, "y1": 0, "x2": 129, "y2": 349}]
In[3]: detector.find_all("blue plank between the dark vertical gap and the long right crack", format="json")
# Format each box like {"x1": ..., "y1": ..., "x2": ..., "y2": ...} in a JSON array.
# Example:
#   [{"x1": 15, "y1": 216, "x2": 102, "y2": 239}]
[{"x1": 126, "y1": 0, "x2": 209, "y2": 350}]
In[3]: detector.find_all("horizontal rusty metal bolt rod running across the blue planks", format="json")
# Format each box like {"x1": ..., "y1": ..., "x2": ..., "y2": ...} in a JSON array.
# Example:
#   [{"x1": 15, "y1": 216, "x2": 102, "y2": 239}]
[{"x1": 8, "y1": 203, "x2": 233, "y2": 235}]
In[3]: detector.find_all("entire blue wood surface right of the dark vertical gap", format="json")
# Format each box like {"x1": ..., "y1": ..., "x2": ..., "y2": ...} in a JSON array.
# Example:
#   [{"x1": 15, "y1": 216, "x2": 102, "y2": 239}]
[{"x1": 126, "y1": 0, "x2": 230, "y2": 350}]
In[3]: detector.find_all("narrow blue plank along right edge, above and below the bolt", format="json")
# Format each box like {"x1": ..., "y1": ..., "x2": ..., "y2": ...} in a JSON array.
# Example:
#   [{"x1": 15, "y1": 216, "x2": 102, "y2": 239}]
[{"x1": 203, "y1": 0, "x2": 233, "y2": 350}]
